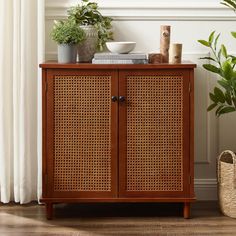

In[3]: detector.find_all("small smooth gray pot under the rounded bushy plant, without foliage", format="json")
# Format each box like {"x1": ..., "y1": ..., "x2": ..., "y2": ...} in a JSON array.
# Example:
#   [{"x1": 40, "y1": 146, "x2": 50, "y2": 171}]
[{"x1": 57, "y1": 44, "x2": 78, "y2": 63}]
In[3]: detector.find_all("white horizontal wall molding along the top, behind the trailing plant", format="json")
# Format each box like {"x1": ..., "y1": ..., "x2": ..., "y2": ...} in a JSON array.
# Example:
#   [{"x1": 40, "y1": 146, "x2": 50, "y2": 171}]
[{"x1": 46, "y1": 0, "x2": 236, "y2": 21}]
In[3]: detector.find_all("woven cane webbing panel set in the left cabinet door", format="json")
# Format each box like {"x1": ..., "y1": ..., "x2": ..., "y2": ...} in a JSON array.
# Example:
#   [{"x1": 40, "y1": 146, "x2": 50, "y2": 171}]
[{"x1": 54, "y1": 76, "x2": 111, "y2": 191}]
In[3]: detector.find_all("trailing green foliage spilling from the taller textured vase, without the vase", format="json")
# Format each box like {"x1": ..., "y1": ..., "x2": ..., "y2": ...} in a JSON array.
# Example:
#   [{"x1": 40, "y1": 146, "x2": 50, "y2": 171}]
[{"x1": 68, "y1": 0, "x2": 113, "y2": 50}]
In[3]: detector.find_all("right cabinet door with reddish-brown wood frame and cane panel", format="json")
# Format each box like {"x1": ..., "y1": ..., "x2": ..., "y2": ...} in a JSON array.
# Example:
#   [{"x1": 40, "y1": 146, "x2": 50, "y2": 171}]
[{"x1": 119, "y1": 69, "x2": 190, "y2": 198}]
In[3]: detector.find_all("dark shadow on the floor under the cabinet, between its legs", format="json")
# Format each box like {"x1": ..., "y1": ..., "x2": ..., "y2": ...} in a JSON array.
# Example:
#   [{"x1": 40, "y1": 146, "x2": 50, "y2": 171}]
[{"x1": 54, "y1": 203, "x2": 183, "y2": 218}]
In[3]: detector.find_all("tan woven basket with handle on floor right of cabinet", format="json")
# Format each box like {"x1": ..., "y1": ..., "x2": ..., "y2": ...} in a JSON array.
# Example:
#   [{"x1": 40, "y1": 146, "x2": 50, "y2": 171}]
[{"x1": 218, "y1": 151, "x2": 236, "y2": 218}]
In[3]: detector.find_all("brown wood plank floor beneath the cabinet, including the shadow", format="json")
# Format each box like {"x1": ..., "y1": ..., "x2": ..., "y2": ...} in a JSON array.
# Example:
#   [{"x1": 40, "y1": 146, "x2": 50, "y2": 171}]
[{"x1": 0, "y1": 202, "x2": 236, "y2": 236}]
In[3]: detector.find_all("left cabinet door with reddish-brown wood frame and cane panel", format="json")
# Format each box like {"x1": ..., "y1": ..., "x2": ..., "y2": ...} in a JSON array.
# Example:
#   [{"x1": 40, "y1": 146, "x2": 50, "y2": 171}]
[{"x1": 44, "y1": 69, "x2": 118, "y2": 199}]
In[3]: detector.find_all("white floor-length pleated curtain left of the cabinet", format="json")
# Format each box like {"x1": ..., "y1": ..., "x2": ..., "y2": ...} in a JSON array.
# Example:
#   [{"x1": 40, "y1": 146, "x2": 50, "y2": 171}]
[{"x1": 0, "y1": 0, "x2": 44, "y2": 203}]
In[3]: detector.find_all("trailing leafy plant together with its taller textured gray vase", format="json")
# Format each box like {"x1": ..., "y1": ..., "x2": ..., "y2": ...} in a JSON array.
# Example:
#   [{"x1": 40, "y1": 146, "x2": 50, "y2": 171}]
[{"x1": 68, "y1": 0, "x2": 113, "y2": 62}]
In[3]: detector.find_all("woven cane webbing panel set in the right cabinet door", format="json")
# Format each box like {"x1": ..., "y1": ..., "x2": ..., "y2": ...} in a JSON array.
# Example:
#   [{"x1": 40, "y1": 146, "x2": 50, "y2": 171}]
[{"x1": 126, "y1": 76, "x2": 183, "y2": 191}]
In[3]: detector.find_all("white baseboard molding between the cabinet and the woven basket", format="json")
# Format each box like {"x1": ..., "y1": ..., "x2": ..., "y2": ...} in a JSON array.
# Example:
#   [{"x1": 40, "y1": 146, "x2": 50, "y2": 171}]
[{"x1": 194, "y1": 179, "x2": 218, "y2": 201}]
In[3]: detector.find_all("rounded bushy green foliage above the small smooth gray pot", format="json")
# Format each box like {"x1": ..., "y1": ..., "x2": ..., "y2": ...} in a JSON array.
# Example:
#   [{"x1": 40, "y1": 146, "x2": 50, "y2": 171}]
[{"x1": 51, "y1": 19, "x2": 85, "y2": 44}]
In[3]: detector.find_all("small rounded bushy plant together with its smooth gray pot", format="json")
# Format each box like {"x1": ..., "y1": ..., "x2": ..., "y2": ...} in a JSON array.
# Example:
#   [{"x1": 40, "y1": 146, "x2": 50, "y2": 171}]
[{"x1": 51, "y1": 19, "x2": 85, "y2": 63}]
